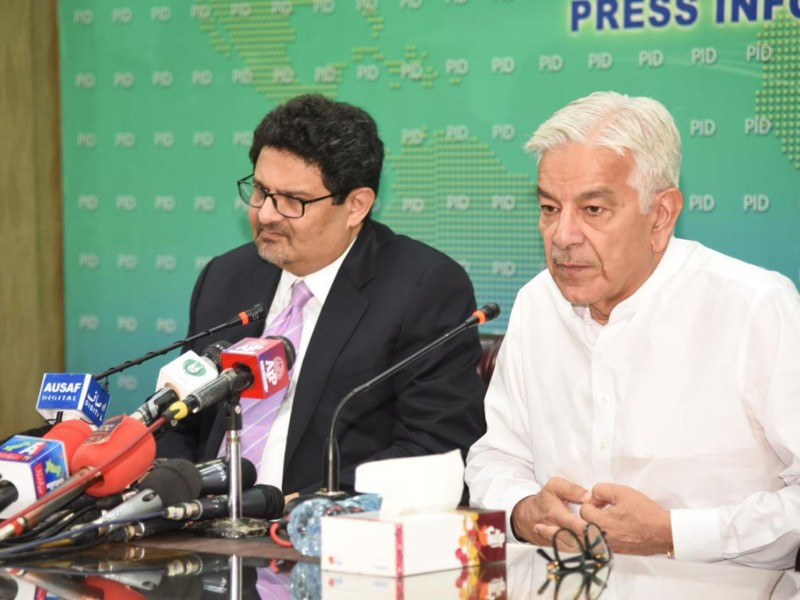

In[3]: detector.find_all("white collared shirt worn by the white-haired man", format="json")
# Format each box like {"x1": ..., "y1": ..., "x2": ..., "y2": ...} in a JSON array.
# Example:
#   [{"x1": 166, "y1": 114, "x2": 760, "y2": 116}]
[{"x1": 466, "y1": 239, "x2": 800, "y2": 568}]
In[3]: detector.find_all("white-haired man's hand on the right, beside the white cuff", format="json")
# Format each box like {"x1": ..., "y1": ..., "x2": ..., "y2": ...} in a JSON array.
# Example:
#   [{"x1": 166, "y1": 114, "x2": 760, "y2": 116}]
[{"x1": 581, "y1": 483, "x2": 672, "y2": 556}]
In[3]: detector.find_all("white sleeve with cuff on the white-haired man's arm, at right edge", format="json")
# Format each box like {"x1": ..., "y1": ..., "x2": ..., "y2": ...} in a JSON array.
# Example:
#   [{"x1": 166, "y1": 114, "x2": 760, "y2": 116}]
[{"x1": 671, "y1": 278, "x2": 800, "y2": 569}]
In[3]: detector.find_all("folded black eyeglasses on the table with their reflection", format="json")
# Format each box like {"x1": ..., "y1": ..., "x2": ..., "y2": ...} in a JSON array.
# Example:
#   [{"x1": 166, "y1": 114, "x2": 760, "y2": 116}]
[{"x1": 536, "y1": 523, "x2": 614, "y2": 600}]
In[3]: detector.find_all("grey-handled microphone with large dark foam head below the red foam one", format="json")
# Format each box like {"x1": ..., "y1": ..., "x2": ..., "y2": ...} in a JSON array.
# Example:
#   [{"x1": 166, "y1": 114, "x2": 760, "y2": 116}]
[{"x1": 87, "y1": 458, "x2": 203, "y2": 535}]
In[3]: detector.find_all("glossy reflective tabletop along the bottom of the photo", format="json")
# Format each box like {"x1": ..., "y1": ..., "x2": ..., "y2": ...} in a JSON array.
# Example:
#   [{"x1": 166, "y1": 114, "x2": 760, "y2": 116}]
[{"x1": 0, "y1": 533, "x2": 800, "y2": 600}]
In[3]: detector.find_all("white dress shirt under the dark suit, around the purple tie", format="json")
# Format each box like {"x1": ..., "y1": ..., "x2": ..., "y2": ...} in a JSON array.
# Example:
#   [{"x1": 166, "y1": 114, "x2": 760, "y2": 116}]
[{"x1": 236, "y1": 240, "x2": 355, "y2": 488}]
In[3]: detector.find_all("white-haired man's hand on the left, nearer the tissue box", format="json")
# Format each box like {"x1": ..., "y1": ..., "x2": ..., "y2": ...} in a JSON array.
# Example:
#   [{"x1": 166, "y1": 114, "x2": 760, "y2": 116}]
[{"x1": 511, "y1": 477, "x2": 591, "y2": 546}]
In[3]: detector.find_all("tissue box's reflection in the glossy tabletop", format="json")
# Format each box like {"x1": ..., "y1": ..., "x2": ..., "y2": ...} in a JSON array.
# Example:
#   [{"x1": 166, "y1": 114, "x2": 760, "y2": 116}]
[{"x1": 322, "y1": 562, "x2": 508, "y2": 600}]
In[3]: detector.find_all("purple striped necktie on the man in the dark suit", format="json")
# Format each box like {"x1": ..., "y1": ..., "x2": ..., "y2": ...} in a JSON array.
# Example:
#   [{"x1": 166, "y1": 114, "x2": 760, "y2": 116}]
[{"x1": 241, "y1": 279, "x2": 314, "y2": 469}]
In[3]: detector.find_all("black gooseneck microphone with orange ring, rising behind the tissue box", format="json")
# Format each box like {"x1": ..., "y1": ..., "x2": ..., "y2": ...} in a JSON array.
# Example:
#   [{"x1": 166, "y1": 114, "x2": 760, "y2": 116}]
[{"x1": 317, "y1": 302, "x2": 500, "y2": 497}]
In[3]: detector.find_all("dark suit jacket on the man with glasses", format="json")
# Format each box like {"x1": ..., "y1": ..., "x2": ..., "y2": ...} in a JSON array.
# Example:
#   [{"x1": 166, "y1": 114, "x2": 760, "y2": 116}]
[{"x1": 153, "y1": 221, "x2": 486, "y2": 493}]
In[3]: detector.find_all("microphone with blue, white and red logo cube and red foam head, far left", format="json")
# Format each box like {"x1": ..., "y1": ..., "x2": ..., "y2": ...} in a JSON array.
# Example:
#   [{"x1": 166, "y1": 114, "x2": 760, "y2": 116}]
[{"x1": 0, "y1": 421, "x2": 92, "y2": 516}]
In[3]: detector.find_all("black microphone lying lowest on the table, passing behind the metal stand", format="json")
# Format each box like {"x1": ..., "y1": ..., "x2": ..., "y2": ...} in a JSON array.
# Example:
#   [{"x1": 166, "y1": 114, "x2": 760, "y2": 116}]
[{"x1": 164, "y1": 483, "x2": 284, "y2": 521}]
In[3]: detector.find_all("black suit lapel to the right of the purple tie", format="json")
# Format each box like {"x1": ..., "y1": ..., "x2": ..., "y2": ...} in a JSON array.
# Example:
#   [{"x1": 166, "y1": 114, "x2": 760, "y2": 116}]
[{"x1": 284, "y1": 221, "x2": 378, "y2": 466}]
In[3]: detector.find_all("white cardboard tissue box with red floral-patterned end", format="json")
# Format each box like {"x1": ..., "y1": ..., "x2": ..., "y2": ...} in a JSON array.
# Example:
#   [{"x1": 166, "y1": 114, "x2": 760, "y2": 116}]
[{"x1": 320, "y1": 508, "x2": 506, "y2": 577}]
